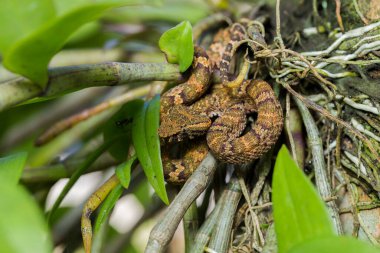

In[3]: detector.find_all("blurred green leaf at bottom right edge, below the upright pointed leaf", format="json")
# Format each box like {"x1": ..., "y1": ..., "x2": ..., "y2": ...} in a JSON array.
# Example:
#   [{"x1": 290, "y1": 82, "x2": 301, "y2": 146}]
[{"x1": 289, "y1": 236, "x2": 380, "y2": 253}]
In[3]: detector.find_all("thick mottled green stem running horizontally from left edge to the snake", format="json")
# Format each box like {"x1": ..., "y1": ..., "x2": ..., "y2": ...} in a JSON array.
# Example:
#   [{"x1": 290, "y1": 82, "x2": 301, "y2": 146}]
[{"x1": 0, "y1": 62, "x2": 182, "y2": 111}]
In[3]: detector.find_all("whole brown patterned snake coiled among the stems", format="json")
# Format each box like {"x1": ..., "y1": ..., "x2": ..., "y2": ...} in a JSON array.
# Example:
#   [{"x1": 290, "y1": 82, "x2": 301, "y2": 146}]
[{"x1": 159, "y1": 20, "x2": 283, "y2": 184}]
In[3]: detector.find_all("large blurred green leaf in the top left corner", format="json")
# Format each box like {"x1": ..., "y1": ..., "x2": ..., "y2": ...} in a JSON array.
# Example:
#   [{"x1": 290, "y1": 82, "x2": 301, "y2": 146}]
[{"x1": 0, "y1": 0, "x2": 157, "y2": 87}]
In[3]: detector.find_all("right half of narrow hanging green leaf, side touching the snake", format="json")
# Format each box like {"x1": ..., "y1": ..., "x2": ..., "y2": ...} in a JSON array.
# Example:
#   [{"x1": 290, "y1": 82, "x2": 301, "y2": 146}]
[{"x1": 145, "y1": 95, "x2": 169, "y2": 204}]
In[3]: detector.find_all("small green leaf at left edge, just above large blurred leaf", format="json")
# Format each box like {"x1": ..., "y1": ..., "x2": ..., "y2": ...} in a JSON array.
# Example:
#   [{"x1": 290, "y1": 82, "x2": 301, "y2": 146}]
[{"x1": 0, "y1": 152, "x2": 28, "y2": 184}]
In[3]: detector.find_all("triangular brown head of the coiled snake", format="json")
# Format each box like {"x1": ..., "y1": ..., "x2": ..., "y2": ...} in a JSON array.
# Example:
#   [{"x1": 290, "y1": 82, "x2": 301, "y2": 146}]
[{"x1": 158, "y1": 105, "x2": 211, "y2": 142}]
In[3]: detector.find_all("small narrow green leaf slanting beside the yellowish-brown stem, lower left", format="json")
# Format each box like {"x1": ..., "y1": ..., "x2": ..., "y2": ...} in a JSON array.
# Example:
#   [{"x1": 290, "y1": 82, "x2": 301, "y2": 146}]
[{"x1": 94, "y1": 184, "x2": 124, "y2": 233}]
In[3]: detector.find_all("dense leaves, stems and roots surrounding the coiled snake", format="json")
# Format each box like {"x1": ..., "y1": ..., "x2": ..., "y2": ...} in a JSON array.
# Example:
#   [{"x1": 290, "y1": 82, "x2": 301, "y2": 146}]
[{"x1": 0, "y1": 0, "x2": 380, "y2": 253}]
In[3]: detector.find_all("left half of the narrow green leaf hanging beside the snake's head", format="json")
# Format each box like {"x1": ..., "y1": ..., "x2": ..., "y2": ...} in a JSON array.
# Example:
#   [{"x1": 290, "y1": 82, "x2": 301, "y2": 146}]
[{"x1": 132, "y1": 98, "x2": 169, "y2": 204}]
